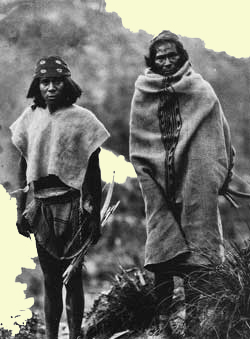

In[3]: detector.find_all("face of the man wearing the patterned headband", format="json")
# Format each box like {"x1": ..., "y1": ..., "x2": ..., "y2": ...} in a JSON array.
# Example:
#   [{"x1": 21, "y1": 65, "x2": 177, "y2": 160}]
[{"x1": 39, "y1": 77, "x2": 64, "y2": 106}]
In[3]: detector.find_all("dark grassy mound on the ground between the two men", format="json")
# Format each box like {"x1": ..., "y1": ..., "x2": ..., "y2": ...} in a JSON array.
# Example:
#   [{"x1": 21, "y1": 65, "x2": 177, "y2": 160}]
[{"x1": 86, "y1": 269, "x2": 157, "y2": 338}]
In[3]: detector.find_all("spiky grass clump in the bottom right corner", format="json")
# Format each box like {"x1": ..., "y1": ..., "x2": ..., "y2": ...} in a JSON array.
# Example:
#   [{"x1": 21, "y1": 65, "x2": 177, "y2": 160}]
[{"x1": 187, "y1": 244, "x2": 250, "y2": 339}]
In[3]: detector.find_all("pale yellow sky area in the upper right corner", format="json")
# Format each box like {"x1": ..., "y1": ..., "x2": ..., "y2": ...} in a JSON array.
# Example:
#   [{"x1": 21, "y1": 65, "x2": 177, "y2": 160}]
[{"x1": 106, "y1": 0, "x2": 250, "y2": 58}]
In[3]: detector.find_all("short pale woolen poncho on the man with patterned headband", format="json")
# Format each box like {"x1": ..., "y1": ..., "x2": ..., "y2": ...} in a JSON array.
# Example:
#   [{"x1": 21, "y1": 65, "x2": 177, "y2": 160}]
[{"x1": 10, "y1": 104, "x2": 109, "y2": 190}]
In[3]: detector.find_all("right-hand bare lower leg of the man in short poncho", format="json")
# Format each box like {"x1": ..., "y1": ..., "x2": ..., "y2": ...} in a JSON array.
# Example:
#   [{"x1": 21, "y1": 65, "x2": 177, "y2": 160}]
[{"x1": 66, "y1": 270, "x2": 84, "y2": 339}]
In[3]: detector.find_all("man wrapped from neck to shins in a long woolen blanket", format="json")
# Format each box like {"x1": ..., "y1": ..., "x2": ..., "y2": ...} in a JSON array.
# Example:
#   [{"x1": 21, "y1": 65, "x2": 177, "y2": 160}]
[{"x1": 130, "y1": 31, "x2": 237, "y2": 338}]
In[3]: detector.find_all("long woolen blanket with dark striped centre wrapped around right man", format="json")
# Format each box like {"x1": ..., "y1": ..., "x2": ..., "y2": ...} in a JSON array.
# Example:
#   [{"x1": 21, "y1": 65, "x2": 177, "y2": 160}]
[{"x1": 130, "y1": 62, "x2": 232, "y2": 269}]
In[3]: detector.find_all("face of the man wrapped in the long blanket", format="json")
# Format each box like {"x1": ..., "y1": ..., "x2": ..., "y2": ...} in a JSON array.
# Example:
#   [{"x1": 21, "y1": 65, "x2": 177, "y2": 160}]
[{"x1": 154, "y1": 41, "x2": 181, "y2": 76}]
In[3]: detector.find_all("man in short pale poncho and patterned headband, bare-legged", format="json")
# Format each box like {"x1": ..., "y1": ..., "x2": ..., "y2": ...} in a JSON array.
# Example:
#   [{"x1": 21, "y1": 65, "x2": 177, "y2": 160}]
[{"x1": 10, "y1": 56, "x2": 109, "y2": 339}]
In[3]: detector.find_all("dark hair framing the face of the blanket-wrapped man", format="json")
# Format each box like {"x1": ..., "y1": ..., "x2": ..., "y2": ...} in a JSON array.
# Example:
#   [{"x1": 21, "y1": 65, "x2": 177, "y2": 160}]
[{"x1": 144, "y1": 39, "x2": 189, "y2": 72}]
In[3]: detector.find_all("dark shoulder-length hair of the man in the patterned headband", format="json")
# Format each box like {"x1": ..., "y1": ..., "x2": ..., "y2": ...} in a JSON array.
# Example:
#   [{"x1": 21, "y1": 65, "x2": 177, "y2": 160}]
[{"x1": 27, "y1": 77, "x2": 82, "y2": 110}]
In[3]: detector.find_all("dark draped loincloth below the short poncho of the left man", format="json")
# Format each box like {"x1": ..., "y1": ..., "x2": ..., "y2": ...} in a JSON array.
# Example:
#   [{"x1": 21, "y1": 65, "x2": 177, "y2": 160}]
[{"x1": 24, "y1": 190, "x2": 90, "y2": 259}]
